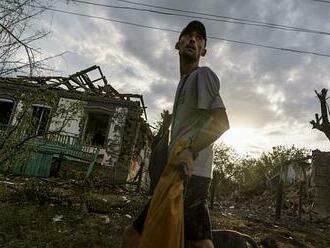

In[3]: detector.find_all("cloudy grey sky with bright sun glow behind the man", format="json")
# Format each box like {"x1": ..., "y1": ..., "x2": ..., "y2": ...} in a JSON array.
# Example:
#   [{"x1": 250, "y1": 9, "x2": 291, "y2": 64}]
[{"x1": 29, "y1": 0, "x2": 330, "y2": 154}]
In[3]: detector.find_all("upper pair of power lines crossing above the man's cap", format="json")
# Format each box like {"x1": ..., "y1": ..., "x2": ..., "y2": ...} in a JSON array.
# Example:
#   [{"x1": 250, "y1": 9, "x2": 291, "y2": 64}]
[{"x1": 67, "y1": 0, "x2": 330, "y2": 35}]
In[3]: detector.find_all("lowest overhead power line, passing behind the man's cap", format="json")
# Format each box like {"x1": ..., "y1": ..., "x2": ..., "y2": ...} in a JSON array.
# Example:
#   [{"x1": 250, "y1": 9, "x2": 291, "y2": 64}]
[{"x1": 40, "y1": 7, "x2": 330, "y2": 57}]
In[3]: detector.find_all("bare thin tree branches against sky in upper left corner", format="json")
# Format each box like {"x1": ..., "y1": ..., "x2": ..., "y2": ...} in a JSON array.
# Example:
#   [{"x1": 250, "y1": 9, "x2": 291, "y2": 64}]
[{"x1": 0, "y1": 0, "x2": 50, "y2": 76}]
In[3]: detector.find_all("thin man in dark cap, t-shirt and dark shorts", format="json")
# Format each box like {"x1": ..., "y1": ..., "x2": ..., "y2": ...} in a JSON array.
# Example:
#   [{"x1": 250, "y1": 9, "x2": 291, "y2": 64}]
[{"x1": 124, "y1": 21, "x2": 229, "y2": 248}]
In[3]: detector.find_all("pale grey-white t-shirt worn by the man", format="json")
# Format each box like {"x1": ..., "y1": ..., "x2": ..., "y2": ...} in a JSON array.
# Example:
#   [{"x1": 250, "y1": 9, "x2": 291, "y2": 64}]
[{"x1": 169, "y1": 67, "x2": 225, "y2": 178}]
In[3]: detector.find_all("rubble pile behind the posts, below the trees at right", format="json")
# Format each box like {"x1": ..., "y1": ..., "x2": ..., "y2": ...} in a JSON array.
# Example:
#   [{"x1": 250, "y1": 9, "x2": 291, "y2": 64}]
[{"x1": 214, "y1": 185, "x2": 330, "y2": 229}]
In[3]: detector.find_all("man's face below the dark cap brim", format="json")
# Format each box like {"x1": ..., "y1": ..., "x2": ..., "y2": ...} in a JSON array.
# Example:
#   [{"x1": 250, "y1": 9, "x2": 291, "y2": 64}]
[{"x1": 176, "y1": 31, "x2": 206, "y2": 62}]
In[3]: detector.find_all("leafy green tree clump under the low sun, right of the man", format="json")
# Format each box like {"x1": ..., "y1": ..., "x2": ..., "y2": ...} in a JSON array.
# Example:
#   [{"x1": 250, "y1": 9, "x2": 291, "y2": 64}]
[{"x1": 211, "y1": 143, "x2": 309, "y2": 203}]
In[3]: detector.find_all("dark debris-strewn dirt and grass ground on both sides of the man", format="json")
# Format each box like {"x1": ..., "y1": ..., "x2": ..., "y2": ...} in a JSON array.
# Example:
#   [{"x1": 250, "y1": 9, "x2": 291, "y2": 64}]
[{"x1": 0, "y1": 172, "x2": 330, "y2": 248}]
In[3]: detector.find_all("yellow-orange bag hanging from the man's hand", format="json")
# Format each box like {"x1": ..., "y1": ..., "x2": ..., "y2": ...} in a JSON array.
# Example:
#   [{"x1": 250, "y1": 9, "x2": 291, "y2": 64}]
[{"x1": 139, "y1": 140, "x2": 189, "y2": 248}]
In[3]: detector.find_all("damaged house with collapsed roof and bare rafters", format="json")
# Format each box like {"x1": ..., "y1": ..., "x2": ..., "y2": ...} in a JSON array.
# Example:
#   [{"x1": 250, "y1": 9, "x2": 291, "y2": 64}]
[{"x1": 0, "y1": 66, "x2": 152, "y2": 181}]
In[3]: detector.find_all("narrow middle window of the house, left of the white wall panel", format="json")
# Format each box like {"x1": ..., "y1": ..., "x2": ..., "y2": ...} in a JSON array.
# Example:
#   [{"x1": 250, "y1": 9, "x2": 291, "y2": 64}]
[{"x1": 32, "y1": 105, "x2": 51, "y2": 135}]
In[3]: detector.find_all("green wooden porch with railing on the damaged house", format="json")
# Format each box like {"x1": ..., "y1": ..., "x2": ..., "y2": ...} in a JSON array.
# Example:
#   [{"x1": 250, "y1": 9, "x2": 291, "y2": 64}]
[{"x1": 0, "y1": 124, "x2": 101, "y2": 178}]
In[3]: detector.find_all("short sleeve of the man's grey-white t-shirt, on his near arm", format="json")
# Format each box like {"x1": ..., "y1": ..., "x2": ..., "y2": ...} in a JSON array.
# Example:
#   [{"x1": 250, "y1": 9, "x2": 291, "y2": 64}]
[{"x1": 197, "y1": 67, "x2": 225, "y2": 109}]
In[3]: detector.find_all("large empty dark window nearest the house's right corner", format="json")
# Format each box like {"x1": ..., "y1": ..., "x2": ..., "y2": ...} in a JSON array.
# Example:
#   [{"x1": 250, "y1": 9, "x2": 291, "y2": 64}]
[{"x1": 85, "y1": 113, "x2": 110, "y2": 146}]
